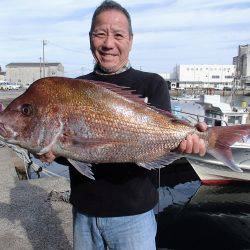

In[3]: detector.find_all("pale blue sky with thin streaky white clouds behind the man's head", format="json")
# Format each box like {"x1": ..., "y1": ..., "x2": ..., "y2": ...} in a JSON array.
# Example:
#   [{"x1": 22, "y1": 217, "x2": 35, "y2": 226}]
[{"x1": 0, "y1": 0, "x2": 250, "y2": 77}]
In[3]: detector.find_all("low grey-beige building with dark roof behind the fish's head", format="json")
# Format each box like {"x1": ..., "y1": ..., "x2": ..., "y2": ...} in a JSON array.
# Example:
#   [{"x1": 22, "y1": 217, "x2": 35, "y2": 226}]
[{"x1": 6, "y1": 63, "x2": 64, "y2": 88}]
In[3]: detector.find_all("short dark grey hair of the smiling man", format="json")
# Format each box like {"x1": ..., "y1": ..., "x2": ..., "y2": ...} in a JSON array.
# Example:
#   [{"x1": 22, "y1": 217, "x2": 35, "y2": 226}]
[{"x1": 89, "y1": 0, "x2": 133, "y2": 36}]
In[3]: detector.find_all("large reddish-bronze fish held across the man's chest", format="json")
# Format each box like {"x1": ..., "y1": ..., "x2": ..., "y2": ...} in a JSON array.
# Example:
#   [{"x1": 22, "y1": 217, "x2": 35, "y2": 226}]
[{"x1": 0, "y1": 77, "x2": 250, "y2": 178}]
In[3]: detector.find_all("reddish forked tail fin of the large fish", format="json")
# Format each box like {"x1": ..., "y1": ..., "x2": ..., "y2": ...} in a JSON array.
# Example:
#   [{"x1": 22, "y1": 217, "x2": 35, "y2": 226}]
[{"x1": 207, "y1": 124, "x2": 250, "y2": 172}]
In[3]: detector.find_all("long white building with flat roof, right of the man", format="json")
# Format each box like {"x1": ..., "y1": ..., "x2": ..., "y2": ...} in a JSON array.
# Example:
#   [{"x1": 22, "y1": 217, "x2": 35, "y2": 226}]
[{"x1": 173, "y1": 64, "x2": 236, "y2": 90}]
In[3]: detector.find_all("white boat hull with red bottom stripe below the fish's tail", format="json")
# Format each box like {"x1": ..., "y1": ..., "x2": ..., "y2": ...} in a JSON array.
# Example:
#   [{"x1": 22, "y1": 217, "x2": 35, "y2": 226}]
[{"x1": 187, "y1": 143, "x2": 250, "y2": 184}]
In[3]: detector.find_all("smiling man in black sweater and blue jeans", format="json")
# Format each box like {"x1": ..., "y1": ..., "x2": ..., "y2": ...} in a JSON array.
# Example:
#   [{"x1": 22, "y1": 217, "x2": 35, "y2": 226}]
[{"x1": 40, "y1": 1, "x2": 206, "y2": 250}]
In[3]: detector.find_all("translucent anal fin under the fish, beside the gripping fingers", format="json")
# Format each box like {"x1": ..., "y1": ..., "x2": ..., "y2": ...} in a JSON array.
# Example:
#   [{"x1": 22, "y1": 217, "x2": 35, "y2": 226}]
[{"x1": 136, "y1": 152, "x2": 183, "y2": 170}]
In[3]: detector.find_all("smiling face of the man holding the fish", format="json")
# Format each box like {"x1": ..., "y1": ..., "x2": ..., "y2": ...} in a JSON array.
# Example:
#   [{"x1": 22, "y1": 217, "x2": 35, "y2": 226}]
[{"x1": 90, "y1": 10, "x2": 133, "y2": 73}]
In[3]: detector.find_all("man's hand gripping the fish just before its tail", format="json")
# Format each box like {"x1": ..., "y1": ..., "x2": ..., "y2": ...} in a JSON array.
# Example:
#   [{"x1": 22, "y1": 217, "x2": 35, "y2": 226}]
[{"x1": 178, "y1": 122, "x2": 207, "y2": 156}]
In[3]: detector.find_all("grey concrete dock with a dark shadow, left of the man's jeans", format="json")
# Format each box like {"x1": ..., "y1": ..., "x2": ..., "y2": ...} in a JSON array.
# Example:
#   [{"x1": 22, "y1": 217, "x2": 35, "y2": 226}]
[{"x1": 0, "y1": 147, "x2": 72, "y2": 250}]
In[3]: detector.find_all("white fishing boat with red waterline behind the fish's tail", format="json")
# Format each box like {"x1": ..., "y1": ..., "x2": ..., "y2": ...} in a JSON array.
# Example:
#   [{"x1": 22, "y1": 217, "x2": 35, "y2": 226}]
[{"x1": 184, "y1": 95, "x2": 250, "y2": 184}]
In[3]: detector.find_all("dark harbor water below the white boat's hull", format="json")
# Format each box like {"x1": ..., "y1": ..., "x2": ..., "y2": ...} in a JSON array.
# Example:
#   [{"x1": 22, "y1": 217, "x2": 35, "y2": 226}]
[{"x1": 157, "y1": 183, "x2": 250, "y2": 250}]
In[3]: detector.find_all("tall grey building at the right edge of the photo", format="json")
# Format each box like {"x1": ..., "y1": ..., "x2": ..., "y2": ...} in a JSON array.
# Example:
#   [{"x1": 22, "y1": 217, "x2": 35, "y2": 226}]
[{"x1": 233, "y1": 44, "x2": 250, "y2": 91}]
